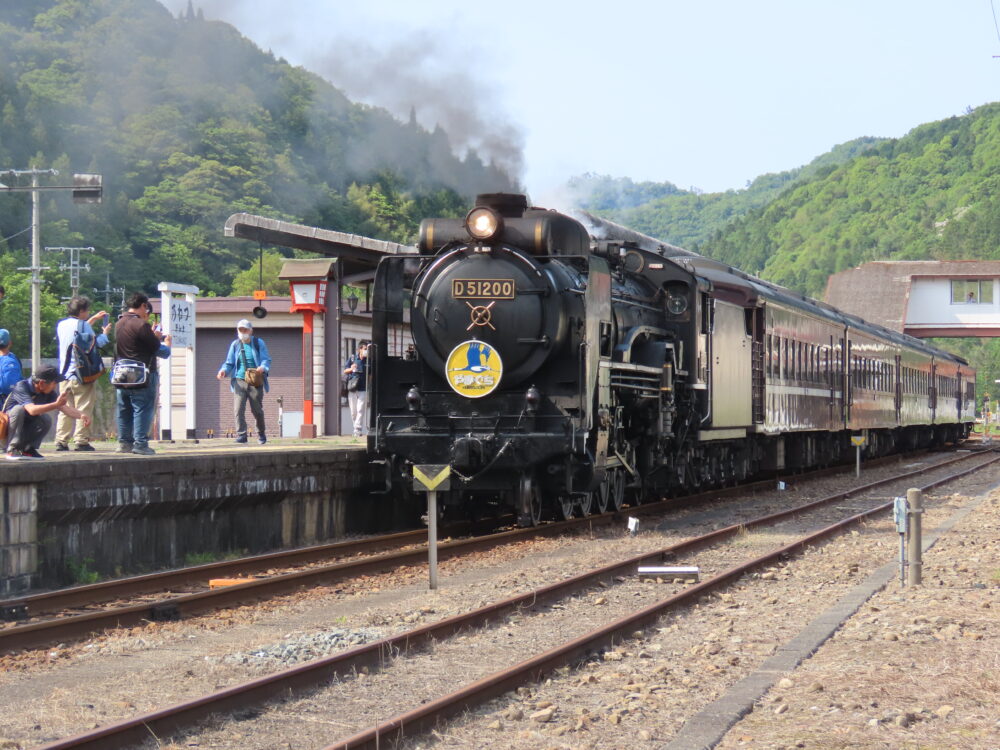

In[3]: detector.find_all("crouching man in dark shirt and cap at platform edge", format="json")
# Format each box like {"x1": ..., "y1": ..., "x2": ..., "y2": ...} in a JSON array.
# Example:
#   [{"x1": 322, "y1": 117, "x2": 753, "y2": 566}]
[{"x1": 3, "y1": 367, "x2": 90, "y2": 461}]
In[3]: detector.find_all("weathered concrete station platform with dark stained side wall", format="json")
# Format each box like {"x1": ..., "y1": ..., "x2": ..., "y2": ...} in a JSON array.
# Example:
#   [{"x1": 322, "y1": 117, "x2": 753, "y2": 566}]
[{"x1": 0, "y1": 437, "x2": 400, "y2": 596}]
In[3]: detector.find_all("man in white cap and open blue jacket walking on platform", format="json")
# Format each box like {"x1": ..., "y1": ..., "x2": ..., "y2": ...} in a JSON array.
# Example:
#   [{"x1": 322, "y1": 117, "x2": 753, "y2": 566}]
[{"x1": 215, "y1": 318, "x2": 271, "y2": 445}]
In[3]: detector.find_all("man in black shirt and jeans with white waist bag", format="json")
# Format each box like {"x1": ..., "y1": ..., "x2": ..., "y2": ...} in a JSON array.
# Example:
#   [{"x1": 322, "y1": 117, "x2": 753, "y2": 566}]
[{"x1": 115, "y1": 292, "x2": 164, "y2": 456}]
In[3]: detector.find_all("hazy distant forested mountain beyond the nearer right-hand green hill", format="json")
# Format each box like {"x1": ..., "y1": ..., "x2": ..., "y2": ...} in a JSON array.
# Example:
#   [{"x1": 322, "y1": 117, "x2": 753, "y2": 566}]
[{"x1": 568, "y1": 138, "x2": 883, "y2": 248}]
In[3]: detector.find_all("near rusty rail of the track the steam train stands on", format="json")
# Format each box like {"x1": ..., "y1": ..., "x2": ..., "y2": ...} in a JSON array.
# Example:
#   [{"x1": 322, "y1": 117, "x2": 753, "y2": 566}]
[{"x1": 0, "y1": 453, "x2": 978, "y2": 654}]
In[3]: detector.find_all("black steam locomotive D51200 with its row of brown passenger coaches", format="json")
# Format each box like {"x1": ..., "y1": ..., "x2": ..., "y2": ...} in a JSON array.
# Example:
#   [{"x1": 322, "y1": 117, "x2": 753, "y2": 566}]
[{"x1": 368, "y1": 194, "x2": 975, "y2": 524}]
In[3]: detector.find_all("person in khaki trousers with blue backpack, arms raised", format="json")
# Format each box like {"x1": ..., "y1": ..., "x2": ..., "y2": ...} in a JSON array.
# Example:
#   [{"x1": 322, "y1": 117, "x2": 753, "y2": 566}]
[{"x1": 56, "y1": 297, "x2": 111, "y2": 451}]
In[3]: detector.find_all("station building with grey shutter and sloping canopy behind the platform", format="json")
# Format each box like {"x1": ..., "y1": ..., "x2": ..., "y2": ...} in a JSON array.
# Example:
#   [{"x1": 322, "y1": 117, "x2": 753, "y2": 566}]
[{"x1": 151, "y1": 213, "x2": 415, "y2": 439}]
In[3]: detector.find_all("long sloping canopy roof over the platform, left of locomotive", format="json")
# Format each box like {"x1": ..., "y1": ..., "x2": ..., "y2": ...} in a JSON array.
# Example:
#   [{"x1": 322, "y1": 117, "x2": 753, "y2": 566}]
[{"x1": 224, "y1": 213, "x2": 417, "y2": 276}]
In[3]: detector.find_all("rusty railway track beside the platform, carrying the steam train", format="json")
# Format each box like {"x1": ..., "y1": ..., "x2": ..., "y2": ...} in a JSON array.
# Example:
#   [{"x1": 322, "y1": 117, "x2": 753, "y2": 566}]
[{"x1": 0, "y1": 454, "x2": 960, "y2": 654}]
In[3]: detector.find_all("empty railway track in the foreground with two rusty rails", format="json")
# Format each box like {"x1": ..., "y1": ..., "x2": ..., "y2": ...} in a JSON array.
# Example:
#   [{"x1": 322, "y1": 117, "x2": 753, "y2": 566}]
[{"x1": 35, "y1": 456, "x2": 1000, "y2": 750}]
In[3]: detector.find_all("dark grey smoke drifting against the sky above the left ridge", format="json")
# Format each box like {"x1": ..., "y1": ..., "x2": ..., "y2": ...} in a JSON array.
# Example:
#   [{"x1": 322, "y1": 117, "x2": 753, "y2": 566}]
[{"x1": 161, "y1": 0, "x2": 524, "y2": 182}]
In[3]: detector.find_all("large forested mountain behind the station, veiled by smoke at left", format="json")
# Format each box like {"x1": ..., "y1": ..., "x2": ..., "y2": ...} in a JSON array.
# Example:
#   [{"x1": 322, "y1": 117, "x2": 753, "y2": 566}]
[{"x1": 0, "y1": 0, "x2": 516, "y2": 352}]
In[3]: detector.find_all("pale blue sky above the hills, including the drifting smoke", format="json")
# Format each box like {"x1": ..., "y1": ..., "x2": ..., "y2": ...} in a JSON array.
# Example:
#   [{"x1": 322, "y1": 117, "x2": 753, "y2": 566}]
[{"x1": 161, "y1": 0, "x2": 1000, "y2": 205}]
